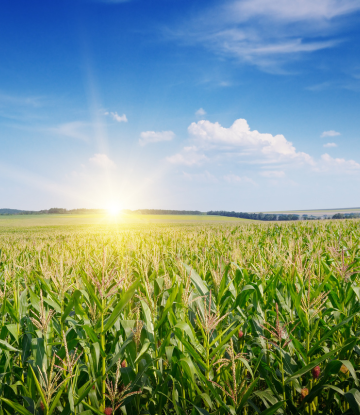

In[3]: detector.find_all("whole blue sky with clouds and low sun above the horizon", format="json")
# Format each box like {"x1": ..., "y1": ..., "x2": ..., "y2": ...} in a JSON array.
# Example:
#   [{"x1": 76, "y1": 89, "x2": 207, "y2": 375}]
[{"x1": 0, "y1": 0, "x2": 360, "y2": 212}]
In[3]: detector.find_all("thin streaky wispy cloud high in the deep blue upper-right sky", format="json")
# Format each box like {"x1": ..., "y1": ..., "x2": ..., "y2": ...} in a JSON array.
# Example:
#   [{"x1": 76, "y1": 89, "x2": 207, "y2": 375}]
[{"x1": 172, "y1": 0, "x2": 360, "y2": 73}]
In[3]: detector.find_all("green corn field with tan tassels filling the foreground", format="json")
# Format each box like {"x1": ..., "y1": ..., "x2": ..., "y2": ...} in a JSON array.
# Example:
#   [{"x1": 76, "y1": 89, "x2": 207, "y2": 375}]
[{"x1": 0, "y1": 220, "x2": 360, "y2": 415}]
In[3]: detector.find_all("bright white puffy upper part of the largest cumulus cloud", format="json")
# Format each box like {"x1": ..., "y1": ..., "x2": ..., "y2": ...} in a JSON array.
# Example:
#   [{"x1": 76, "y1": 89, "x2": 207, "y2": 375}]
[{"x1": 188, "y1": 118, "x2": 313, "y2": 163}]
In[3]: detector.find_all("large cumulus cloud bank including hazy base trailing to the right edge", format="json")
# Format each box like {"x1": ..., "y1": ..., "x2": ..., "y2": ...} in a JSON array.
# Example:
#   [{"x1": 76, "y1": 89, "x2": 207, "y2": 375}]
[{"x1": 167, "y1": 118, "x2": 360, "y2": 177}]
